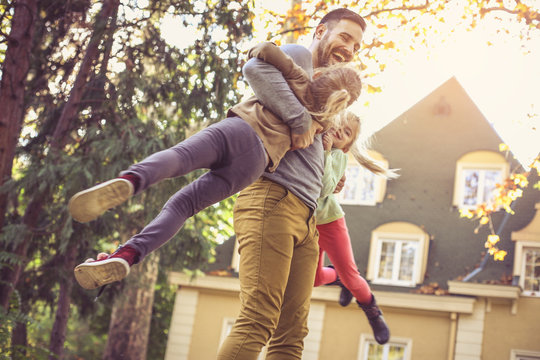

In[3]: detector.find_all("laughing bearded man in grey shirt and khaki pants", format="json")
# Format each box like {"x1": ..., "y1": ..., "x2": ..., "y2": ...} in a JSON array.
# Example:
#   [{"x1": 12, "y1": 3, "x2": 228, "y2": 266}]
[{"x1": 218, "y1": 9, "x2": 366, "y2": 360}]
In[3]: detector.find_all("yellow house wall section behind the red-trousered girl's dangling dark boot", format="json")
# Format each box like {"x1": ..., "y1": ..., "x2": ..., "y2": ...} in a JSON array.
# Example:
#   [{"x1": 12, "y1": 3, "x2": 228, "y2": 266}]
[{"x1": 319, "y1": 304, "x2": 450, "y2": 360}]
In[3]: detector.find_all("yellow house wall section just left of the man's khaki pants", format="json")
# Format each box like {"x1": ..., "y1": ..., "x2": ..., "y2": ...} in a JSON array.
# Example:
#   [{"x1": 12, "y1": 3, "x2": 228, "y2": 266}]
[{"x1": 189, "y1": 290, "x2": 240, "y2": 360}]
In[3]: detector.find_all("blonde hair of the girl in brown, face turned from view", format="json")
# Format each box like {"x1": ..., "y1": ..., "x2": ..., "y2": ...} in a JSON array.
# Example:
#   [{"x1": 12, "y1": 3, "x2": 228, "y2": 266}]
[{"x1": 309, "y1": 63, "x2": 362, "y2": 129}]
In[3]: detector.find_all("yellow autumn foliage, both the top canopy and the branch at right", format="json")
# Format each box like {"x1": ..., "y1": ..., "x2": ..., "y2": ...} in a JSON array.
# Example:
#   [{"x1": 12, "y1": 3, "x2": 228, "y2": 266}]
[{"x1": 262, "y1": 0, "x2": 540, "y2": 260}]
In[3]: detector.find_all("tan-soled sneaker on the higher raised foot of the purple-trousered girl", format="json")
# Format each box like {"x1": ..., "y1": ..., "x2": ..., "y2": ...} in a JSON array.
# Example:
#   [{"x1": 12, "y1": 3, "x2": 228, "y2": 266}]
[{"x1": 68, "y1": 179, "x2": 133, "y2": 222}]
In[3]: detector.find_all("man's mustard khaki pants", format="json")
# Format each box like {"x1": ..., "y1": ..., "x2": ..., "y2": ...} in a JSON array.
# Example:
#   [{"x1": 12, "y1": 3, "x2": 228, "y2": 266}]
[{"x1": 218, "y1": 178, "x2": 319, "y2": 360}]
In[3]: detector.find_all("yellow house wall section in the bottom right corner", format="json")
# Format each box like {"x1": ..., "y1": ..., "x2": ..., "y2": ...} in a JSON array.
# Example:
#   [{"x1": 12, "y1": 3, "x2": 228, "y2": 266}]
[{"x1": 482, "y1": 297, "x2": 540, "y2": 360}]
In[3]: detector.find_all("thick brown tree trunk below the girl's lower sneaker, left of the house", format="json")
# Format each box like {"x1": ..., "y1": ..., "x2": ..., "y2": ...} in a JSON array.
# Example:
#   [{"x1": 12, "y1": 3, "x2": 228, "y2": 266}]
[{"x1": 103, "y1": 252, "x2": 159, "y2": 360}]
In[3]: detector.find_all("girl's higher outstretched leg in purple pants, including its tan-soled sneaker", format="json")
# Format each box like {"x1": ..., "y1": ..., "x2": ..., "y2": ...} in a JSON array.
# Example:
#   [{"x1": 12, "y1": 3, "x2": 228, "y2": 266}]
[{"x1": 68, "y1": 117, "x2": 264, "y2": 222}]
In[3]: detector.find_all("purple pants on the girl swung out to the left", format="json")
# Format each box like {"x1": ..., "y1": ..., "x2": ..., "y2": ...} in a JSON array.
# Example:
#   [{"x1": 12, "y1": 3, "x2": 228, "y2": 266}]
[{"x1": 121, "y1": 117, "x2": 267, "y2": 261}]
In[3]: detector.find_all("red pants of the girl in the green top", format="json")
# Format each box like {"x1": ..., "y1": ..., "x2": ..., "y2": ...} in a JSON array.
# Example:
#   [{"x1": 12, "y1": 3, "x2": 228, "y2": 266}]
[{"x1": 315, "y1": 217, "x2": 371, "y2": 304}]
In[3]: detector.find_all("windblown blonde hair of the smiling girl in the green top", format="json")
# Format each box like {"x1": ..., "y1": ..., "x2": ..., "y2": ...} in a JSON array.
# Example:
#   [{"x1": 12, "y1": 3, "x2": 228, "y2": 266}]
[{"x1": 337, "y1": 111, "x2": 399, "y2": 179}]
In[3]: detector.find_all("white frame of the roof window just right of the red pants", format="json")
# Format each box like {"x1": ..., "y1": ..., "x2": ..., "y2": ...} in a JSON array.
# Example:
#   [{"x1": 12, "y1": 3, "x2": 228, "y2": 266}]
[{"x1": 368, "y1": 232, "x2": 428, "y2": 287}]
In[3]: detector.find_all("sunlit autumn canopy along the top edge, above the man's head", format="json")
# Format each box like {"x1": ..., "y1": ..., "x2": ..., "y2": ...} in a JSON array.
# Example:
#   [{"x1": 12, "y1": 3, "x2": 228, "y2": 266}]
[{"x1": 261, "y1": 0, "x2": 540, "y2": 93}]
